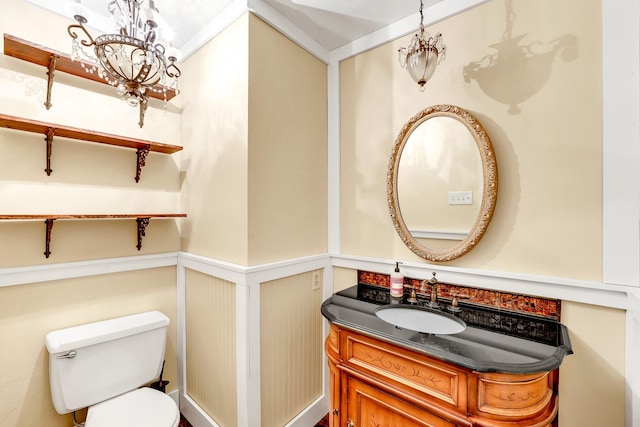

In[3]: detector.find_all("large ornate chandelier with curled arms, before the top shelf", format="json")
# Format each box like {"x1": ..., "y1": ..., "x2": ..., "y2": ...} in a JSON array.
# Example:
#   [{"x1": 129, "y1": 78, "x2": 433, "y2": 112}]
[{"x1": 67, "y1": 0, "x2": 181, "y2": 127}]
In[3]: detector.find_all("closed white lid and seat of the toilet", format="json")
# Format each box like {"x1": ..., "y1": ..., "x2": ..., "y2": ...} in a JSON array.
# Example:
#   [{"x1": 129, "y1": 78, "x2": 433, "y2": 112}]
[{"x1": 85, "y1": 387, "x2": 180, "y2": 427}]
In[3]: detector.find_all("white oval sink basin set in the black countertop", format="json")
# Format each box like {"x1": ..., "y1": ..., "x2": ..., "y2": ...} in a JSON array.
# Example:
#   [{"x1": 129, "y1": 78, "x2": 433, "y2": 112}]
[{"x1": 376, "y1": 305, "x2": 467, "y2": 334}]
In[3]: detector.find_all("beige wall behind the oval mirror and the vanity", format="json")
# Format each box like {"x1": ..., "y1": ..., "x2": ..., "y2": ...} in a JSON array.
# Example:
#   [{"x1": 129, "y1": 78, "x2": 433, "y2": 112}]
[{"x1": 336, "y1": 0, "x2": 625, "y2": 427}]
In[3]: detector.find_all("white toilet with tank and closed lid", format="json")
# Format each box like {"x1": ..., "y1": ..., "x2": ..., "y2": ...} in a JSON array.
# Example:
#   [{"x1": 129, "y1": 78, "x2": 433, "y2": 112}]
[{"x1": 46, "y1": 311, "x2": 180, "y2": 427}]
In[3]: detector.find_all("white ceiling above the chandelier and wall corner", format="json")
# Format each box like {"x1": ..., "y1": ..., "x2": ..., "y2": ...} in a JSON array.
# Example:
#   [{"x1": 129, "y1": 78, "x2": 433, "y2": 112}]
[{"x1": 25, "y1": 0, "x2": 442, "y2": 59}]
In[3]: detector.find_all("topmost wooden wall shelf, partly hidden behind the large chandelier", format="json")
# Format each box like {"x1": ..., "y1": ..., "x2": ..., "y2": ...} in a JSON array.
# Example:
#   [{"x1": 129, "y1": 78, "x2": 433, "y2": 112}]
[{"x1": 4, "y1": 33, "x2": 176, "y2": 110}]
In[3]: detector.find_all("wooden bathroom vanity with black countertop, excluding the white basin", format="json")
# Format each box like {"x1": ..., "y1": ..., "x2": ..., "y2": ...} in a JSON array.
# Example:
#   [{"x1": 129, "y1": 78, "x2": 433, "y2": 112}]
[{"x1": 321, "y1": 285, "x2": 572, "y2": 427}]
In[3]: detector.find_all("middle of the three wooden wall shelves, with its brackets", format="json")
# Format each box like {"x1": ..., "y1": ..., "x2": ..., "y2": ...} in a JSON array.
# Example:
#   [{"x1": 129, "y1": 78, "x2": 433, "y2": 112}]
[{"x1": 0, "y1": 114, "x2": 182, "y2": 182}]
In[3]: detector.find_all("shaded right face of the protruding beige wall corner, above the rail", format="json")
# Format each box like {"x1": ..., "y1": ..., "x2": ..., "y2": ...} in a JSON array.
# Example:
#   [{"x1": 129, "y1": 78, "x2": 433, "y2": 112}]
[{"x1": 249, "y1": 15, "x2": 327, "y2": 264}]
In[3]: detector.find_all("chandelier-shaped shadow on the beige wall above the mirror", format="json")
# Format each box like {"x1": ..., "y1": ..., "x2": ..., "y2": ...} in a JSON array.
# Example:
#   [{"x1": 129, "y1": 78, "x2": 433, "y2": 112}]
[{"x1": 463, "y1": 0, "x2": 578, "y2": 114}]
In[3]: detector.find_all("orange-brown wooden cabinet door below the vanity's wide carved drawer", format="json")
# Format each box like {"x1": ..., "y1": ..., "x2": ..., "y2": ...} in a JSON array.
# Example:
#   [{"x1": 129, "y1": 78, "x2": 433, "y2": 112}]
[{"x1": 342, "y1": 376, "x2": 455, "y2": 427}]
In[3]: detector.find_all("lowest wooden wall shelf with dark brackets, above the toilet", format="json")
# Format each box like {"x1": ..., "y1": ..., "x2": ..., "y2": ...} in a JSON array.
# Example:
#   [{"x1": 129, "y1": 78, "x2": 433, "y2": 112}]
[{"x1": 0, "y1": 214, "x2": 187, "y2": 258}]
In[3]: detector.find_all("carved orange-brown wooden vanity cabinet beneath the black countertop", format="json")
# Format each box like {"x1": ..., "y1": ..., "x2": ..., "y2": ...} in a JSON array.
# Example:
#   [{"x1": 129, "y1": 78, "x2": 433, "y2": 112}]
[{"x1": 325, "y1": 324, "x2": 558, "y2": 427}]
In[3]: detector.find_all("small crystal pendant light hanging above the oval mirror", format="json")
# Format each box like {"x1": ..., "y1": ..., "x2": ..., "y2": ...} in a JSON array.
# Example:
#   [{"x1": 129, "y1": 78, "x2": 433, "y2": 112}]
[{"x1": 398, "y1": 0, "x2": 447, "y2": 92}]
